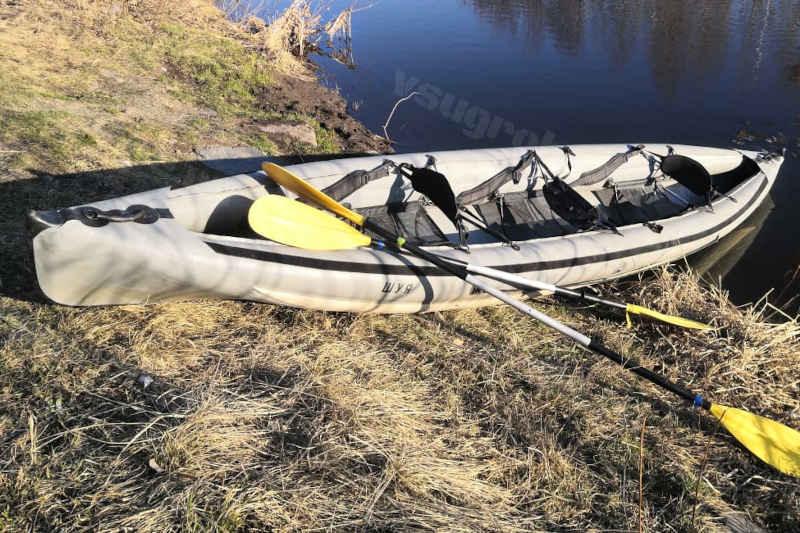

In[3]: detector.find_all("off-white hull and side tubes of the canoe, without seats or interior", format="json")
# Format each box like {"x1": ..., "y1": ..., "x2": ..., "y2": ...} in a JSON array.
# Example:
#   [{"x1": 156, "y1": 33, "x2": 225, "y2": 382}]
[{"x1": 33, "y1": 145, "x2": 783, "y2": 313}]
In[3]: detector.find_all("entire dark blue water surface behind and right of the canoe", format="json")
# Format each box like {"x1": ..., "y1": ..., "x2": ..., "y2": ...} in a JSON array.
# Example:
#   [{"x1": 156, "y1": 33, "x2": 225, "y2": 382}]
[{"x1": 265, "y1": 0, "x2": 800, "y2": 302}]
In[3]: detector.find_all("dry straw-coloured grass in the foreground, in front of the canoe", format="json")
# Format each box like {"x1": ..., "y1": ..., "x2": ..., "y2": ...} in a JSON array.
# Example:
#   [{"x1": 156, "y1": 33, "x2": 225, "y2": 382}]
[{"x1": 0, "y1": 270, "x2": 800, "y2": 531}]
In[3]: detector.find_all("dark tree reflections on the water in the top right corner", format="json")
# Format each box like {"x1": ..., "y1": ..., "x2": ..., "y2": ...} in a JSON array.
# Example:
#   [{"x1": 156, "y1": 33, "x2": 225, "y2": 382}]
[{"x1": 466, "y1": 0, "x2": 800, "y2": 97}]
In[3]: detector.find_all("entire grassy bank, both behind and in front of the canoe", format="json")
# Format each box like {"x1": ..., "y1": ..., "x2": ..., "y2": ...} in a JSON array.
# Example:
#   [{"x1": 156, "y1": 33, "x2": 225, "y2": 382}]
[{"x1": 0, "y1": 0, "x2": 800, "y2": 532}]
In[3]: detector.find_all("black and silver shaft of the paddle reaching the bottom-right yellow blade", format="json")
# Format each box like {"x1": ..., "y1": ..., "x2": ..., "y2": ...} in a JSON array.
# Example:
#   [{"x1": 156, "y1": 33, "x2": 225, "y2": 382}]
[{"x1": 363, "y1": 218, "x2": 711, "y2": 410}]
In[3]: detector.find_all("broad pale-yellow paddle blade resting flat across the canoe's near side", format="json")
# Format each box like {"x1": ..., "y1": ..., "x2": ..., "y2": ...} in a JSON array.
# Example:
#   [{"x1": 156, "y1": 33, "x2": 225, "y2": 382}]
[{"x1": 247, "y1": 194, "x2": 372, "y2": 250}]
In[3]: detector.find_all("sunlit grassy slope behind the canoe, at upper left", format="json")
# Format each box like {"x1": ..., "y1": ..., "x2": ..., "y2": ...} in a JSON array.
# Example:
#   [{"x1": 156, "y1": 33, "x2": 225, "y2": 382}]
[{"x1": 0, "y1": 0, "x2": 382, "y2": 173}]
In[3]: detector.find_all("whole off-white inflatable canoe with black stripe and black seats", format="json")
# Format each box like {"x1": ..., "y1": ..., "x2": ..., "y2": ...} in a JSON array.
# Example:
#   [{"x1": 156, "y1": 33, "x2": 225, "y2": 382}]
[{"x1": 29, "y1": 144, "x2": 783, "y2": 313}]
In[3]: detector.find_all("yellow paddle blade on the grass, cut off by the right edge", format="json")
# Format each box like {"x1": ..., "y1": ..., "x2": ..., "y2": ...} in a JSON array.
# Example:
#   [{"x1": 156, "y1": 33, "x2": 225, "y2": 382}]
[{"x1": 711, "y1": 404, "x2": 800, "y2": 477}]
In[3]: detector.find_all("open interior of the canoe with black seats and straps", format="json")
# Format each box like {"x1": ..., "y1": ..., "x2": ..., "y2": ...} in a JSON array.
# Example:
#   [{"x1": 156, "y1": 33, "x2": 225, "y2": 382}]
[{"x1": 162, "y1": 145, "x2": 761, "y2": 245}]
